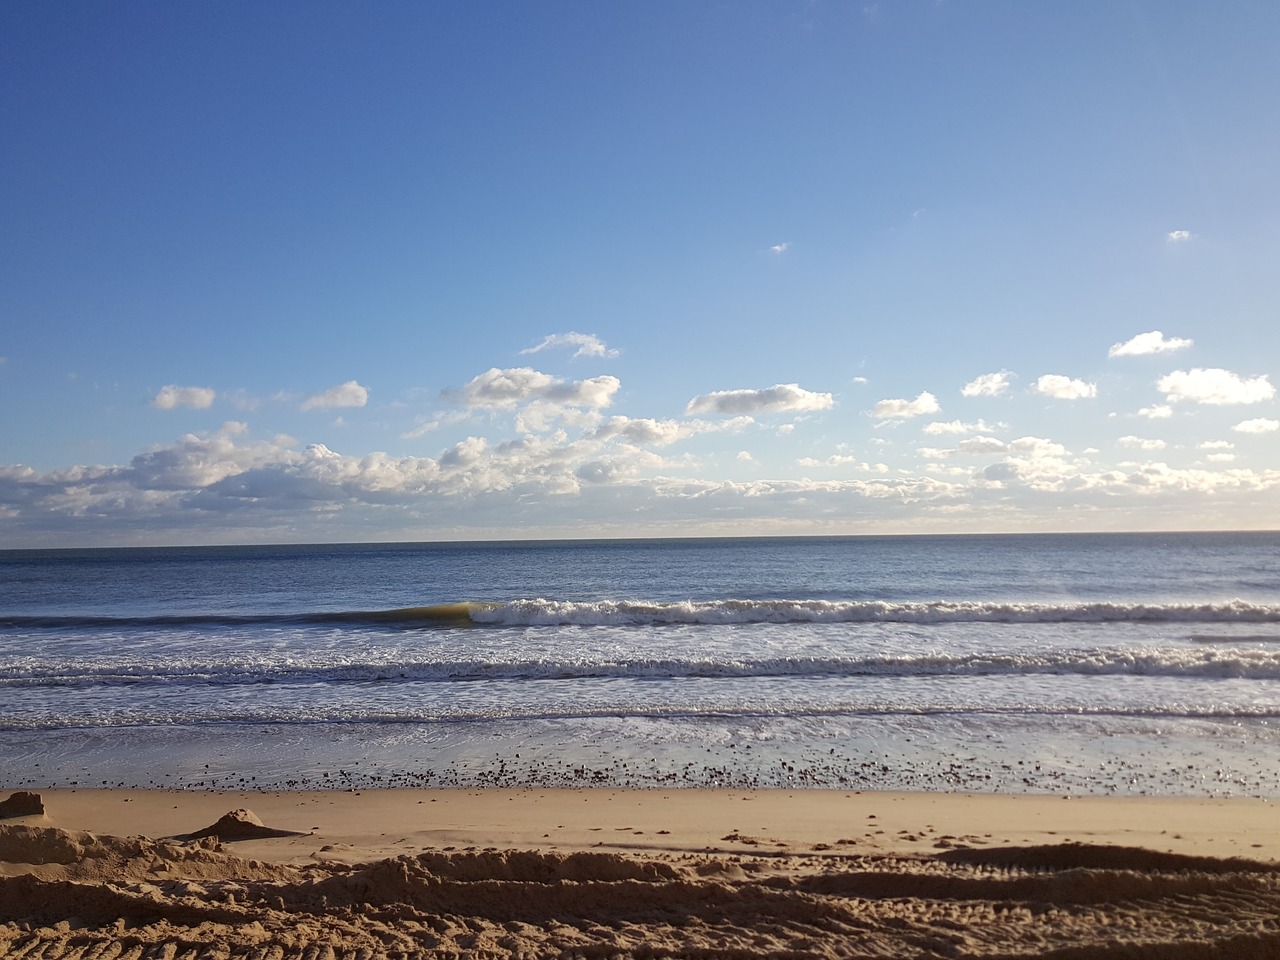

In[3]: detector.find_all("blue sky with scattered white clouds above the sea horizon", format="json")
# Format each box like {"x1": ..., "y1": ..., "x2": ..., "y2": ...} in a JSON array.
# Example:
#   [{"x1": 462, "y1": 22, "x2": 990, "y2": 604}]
[{"x1": 0, "y1": 0, "x2": 1280, "y2": 548}]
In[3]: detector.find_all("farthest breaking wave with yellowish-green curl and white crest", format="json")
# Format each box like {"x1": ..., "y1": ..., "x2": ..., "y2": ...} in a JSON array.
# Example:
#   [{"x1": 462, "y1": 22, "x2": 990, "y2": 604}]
[{"x1": 0, "y1": 599, "x2": 1280, "y2": 628}]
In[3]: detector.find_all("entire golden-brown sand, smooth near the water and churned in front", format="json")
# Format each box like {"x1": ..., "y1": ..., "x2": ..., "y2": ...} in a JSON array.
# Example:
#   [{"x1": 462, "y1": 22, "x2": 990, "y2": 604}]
[{"x1": 0, "y1": 788, "x2": 1280, "y2": 960}]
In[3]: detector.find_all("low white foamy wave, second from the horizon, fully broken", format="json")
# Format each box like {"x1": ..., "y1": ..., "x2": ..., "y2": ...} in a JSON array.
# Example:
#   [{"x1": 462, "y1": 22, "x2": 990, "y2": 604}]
[{"x1": 0, "y1": 648, "x2": 1280, "y2": 689}]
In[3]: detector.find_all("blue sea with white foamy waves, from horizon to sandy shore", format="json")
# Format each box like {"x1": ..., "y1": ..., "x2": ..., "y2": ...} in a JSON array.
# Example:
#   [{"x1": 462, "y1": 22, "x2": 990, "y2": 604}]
[{"x1": 0, "y1": 532, "x2": 1280, "y2": 797}]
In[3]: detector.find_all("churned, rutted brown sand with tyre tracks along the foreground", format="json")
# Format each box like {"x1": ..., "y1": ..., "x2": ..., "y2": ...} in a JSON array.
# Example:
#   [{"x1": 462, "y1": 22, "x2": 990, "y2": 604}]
[{"x1": 0, "y1": 827, "x2": 1280, "y2": 960}]
